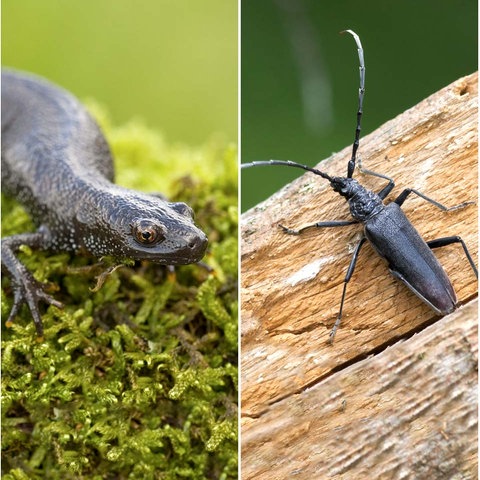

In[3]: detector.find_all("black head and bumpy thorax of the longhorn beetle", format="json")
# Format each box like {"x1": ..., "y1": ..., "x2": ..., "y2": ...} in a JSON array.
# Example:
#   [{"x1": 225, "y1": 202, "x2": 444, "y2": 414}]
[{"x1": 330, "y1": 177, "x2": 385, "y2": 222}]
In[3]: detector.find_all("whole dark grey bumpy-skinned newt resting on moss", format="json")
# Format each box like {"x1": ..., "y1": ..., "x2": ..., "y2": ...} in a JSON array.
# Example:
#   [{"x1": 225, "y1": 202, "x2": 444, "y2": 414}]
[{"x1": 1, "y1": 70, "x2": 207, "y2": 335}]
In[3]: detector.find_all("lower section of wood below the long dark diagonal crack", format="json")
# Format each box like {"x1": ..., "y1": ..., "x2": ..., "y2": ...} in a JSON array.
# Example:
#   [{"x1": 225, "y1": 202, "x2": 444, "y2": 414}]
[{"x1": 242, "y1": 300, "x2": 478, "y2": 480}]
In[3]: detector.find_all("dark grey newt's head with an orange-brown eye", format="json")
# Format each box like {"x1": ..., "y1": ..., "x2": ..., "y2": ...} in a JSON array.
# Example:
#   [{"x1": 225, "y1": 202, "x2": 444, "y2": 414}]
[{"x1": 77, "y1": 188, "x2": 208, "y2": 265}]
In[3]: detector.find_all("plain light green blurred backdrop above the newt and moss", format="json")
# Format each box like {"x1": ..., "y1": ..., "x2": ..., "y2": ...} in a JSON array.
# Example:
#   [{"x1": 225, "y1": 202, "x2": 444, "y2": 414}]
[{"x1": 2, "y1": 0, "x2": 238, "y2": 145}]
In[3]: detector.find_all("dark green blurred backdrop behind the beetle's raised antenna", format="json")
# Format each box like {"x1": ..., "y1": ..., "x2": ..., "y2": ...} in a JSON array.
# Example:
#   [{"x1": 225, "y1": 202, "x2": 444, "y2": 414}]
[{"x1": 241, "y1": 0, "x2": 477, "y2": 210}]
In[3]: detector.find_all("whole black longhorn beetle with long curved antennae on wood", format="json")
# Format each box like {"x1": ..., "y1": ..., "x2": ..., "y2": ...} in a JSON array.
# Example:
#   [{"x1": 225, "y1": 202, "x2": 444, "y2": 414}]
[{"x1": 242, "y1": 30, "x2": 478, "y2": 343}]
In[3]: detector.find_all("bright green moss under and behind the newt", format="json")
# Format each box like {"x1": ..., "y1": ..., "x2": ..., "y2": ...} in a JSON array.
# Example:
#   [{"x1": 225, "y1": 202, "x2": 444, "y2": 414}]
[{"x1": 1, "y1": 106, "x2": 238, "y2": 480}]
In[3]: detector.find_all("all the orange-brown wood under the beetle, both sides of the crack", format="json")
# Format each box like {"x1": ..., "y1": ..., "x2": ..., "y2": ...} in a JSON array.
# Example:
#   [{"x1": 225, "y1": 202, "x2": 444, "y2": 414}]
[{"x1": 241, "y1": 74, "x2": 478, "y2": 479}]
